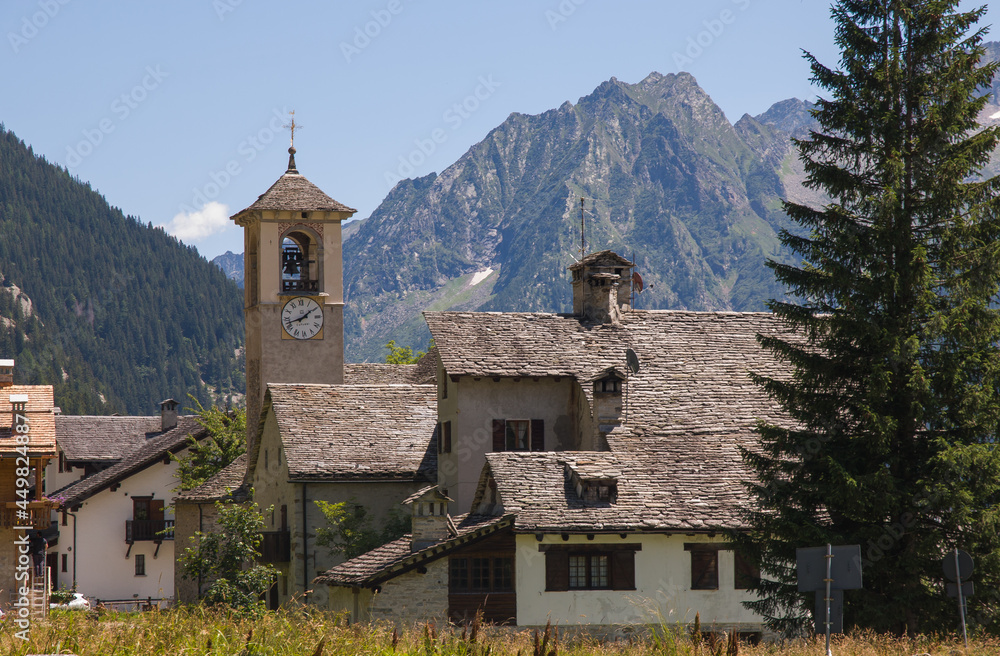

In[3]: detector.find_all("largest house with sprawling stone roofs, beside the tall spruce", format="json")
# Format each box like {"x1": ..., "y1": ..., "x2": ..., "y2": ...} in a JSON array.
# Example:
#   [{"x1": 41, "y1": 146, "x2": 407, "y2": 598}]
[{"x1": 317, "y1": 251, "x2": 788, "y2": 632}]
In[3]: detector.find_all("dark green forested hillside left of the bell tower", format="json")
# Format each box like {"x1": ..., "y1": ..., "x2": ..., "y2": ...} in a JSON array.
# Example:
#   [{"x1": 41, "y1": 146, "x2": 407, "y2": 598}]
[{"x1": 0, "y1": 124, "x2": 245, "y2": 414}]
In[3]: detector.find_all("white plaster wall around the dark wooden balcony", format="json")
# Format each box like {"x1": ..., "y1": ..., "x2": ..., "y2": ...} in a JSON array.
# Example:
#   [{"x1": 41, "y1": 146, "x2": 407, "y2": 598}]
[{"x1": 58, "y1": 450, "x2": 186, "y2": 599}]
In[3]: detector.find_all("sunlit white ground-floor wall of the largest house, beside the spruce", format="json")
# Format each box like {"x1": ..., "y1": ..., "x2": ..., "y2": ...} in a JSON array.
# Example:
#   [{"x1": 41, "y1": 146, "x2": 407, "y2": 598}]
[{"x1": 515, "y1": 534, "x2": 762, "y2": 630}]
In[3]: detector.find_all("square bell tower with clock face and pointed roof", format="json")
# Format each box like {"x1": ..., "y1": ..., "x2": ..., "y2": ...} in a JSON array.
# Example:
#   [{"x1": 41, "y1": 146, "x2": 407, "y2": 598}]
[{"x1": 230, "y1": 144, "x2": 357, "y2": 450}]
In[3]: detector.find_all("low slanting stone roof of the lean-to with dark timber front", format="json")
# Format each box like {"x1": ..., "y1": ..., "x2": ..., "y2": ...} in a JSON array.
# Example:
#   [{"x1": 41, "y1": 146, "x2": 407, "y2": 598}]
[{"x1": 313, "y1": 515, "x2": 512, "y2": 587}]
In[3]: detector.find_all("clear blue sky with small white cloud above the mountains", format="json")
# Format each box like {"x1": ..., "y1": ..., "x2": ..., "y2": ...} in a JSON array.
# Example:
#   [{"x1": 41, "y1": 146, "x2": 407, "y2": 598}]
[{"x1": 0, "y1": 0, "x2": 1000, "y2": 257}]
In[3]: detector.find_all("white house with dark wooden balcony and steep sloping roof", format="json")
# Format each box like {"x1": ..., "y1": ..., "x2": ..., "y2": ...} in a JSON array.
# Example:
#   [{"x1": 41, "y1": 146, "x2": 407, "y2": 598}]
[{"x1": 51, "y1": 400, "x2": 208, "y2": 607}]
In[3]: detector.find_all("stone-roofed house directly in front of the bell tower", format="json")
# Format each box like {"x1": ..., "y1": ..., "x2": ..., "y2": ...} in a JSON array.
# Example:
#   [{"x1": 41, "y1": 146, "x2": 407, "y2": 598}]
[{"x1": 246, "y1": 384, "x2": 437, "y2": 608}]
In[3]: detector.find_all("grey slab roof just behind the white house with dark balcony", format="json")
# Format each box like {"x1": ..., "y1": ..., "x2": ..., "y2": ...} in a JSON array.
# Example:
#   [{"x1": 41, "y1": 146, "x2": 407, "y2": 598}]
[{"x1": 56, "y1": 415, "x2": 162, "y2": 464}]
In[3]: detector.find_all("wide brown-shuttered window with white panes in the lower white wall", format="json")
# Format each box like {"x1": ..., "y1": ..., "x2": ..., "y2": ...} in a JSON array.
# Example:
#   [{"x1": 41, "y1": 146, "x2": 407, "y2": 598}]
[{"x1": 539, "y1": 544, "x2": 642, "y2": 591}]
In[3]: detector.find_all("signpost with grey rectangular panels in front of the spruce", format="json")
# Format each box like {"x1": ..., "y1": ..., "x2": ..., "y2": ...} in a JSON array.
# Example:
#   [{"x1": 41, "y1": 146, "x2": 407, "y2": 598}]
[{"x1": 795, "y1": 544, "x2": 862, "y2": 656}]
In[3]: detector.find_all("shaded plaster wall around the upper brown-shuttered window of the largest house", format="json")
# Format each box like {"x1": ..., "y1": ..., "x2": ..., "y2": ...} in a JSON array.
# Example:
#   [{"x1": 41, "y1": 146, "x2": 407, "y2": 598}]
[{"x1": 438, "y1": 371, "x2": 581, "y2": 515}]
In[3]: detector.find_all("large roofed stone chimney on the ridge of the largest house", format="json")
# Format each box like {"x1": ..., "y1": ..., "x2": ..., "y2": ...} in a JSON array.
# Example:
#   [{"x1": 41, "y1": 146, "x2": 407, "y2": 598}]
[{"x1": 569, "y1": 251, "x2": 634, "y2": 324}]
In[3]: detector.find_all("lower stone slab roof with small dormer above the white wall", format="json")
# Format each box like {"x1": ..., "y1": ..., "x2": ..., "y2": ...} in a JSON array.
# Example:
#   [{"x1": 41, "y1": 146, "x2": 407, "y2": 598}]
[{"x1": 480, "y1": 431, "x2": 752, "y2": 533}]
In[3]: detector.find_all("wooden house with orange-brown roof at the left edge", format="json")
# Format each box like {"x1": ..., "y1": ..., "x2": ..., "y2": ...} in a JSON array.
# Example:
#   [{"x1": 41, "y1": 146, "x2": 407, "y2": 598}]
[{"x1": 0, "y1": 359, "x2": 56, "y2": 608}]
